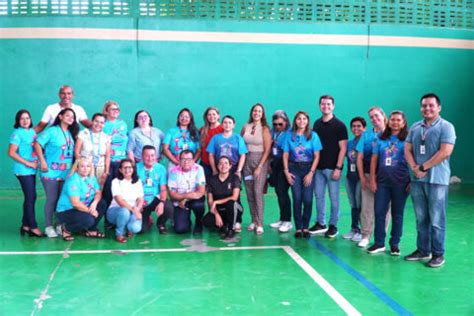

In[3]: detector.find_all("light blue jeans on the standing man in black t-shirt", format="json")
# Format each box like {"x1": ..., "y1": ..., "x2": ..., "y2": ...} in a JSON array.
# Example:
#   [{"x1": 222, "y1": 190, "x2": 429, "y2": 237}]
[{"x1": 314, "y1": 169, "x2": 339, "y2": 226}]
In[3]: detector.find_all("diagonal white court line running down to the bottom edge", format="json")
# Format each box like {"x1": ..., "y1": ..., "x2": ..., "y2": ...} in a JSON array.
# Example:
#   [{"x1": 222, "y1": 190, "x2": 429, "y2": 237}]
[{"x1": 282, "y1": 246, "x2": 361, "y2": 316}]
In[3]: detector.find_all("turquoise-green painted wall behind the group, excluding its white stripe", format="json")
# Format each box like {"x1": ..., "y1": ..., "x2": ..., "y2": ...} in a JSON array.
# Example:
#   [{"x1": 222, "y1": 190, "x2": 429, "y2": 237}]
[{"x1": 0, "y1": 17, "x2": 474, "y2": 187}]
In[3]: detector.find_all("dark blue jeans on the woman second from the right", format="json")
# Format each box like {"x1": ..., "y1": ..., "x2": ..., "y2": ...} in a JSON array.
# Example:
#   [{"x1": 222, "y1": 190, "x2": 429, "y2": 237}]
[{"x1": 374, "y1": 184, "x2": 408, "y2": 247}]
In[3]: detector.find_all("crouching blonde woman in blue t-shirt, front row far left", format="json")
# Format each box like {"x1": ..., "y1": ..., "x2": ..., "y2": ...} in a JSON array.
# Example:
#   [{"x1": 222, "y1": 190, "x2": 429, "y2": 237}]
[{"x1": 57, "y1": 157, "x2": 107, "y2": 241}]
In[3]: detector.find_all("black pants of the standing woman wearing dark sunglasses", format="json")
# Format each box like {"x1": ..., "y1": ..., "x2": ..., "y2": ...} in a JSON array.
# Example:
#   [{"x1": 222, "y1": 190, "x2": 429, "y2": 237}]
[{"x1": 271, "y1": 158, "x2": 291, "y2": 222}]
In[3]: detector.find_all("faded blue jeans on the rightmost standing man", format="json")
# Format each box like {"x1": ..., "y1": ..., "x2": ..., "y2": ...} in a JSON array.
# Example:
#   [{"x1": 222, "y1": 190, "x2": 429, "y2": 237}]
[{"x1": 411, "y1": 182, "x2": 448, "y2": 256}]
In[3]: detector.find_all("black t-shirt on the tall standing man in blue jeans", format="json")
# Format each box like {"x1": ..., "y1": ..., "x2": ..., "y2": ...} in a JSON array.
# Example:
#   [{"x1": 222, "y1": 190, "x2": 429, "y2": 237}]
[{"x1": 313, "y1": 116, "x2": 348, "y2": 169}]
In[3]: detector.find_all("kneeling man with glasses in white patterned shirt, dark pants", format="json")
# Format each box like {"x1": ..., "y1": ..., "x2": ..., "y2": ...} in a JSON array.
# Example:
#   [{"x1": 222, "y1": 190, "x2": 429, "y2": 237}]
[{"x1": 168, "y1": 149, "x2": 206, "y2": 234}]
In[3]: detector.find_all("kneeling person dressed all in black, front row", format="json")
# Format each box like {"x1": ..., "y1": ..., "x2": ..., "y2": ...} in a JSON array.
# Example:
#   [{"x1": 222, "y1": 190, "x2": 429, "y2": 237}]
[{"x1": 203, "y1": 156, "x2": 242, "y2": 239}]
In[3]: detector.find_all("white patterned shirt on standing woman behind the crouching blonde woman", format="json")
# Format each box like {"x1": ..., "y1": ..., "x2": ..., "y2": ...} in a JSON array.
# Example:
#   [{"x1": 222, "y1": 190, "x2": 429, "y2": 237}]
[{"x1": 77, "y1": 128, "x2": 110, "y2": 167}]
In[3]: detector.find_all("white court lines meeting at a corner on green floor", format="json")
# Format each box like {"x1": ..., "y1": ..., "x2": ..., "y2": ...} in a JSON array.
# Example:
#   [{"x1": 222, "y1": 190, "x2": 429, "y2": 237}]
[{"x1": 0, "y1": 246, "x2": 361, "y2": 316}]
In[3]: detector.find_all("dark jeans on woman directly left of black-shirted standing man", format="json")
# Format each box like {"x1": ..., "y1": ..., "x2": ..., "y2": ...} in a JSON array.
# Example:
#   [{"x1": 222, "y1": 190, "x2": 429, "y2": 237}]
[{"x1": 288, "y1": 162, "x2": 314, "y2": 230}]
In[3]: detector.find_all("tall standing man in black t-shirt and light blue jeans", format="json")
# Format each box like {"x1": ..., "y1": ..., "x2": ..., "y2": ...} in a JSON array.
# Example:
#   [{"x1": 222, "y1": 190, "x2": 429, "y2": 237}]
[{"x1": 309, "y1": 95, "x2": 348, "y2": 238}]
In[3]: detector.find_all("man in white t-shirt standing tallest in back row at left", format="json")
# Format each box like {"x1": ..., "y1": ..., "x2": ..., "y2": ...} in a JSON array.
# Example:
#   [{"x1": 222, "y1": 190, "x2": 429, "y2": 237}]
[{"x1": 34, "y1": 85, "x2": 92, "y2": 134}]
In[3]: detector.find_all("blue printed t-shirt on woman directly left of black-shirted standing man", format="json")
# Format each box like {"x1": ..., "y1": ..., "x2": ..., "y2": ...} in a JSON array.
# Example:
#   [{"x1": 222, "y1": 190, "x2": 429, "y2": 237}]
[{"x1": 283, "y1": 132, "x2": 323, "y2": 162}]
